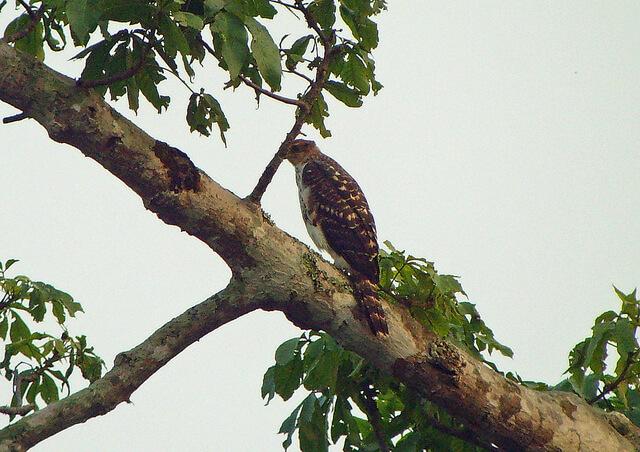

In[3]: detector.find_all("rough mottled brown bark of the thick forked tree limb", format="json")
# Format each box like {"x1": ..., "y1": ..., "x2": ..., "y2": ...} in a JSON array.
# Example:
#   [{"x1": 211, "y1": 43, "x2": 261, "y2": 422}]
[{"x1": 0, "y1": 42, "x2": 640, "y2": 451}]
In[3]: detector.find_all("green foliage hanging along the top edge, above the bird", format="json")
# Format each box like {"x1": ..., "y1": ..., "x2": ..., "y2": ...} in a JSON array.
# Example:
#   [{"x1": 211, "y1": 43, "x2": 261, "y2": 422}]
[{"x1": 0, "y1": 0, "x2": 385, "y2": 143}]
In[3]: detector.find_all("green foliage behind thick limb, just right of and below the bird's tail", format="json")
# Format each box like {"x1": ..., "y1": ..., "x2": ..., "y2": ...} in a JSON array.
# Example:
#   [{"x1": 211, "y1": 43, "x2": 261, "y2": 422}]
[{"x1": 262, "y1": 242, "x2": 512, "y2": 452}]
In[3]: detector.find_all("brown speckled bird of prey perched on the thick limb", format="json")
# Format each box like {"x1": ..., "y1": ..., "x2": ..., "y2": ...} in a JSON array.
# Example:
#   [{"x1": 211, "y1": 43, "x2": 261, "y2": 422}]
[{"x1": 285, "y1": 140, "x2": 389, "y2": 336}]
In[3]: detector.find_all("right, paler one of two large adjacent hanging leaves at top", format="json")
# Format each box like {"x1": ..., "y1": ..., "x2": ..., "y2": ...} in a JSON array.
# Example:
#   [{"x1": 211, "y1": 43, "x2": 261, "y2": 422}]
[{"x1": 244, "y1": 17, "x2": 282, "y2": 91}]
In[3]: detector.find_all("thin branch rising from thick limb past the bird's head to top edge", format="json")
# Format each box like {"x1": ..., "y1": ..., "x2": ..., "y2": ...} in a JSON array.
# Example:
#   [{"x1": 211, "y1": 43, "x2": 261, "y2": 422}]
[{"x1": 246, "y1": 0, "x2": 335, "y2": 205}]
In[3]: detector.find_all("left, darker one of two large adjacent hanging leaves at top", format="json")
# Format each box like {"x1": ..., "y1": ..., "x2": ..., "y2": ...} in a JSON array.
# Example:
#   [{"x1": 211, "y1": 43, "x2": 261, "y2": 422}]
[{"x1": 211, "y1": 12, "x2": 249, "y2": 80}]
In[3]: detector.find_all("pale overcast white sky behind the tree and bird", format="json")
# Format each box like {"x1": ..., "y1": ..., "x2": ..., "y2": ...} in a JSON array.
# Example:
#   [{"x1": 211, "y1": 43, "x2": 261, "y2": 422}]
[{"x1": 0, "y1": 1, "x2": 640, "y2": 452}]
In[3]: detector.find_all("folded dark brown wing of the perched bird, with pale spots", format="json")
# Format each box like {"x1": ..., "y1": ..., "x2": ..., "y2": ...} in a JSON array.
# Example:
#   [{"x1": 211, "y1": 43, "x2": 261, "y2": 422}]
[{"x1": 302, "y1": 155, "x2": 379, "y2": 284}]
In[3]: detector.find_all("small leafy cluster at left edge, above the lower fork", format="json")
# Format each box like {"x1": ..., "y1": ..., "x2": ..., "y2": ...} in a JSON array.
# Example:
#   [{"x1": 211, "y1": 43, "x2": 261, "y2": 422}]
[{"x1": 0, "y1": 259, "x2": 104, "y2": 418}]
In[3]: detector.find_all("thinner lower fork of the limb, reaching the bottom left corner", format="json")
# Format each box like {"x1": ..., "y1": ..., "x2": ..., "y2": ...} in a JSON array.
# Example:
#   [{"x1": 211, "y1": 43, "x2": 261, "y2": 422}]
[{"x1": 0, "y1": 283, "x2": 257, "y2": 452}]
